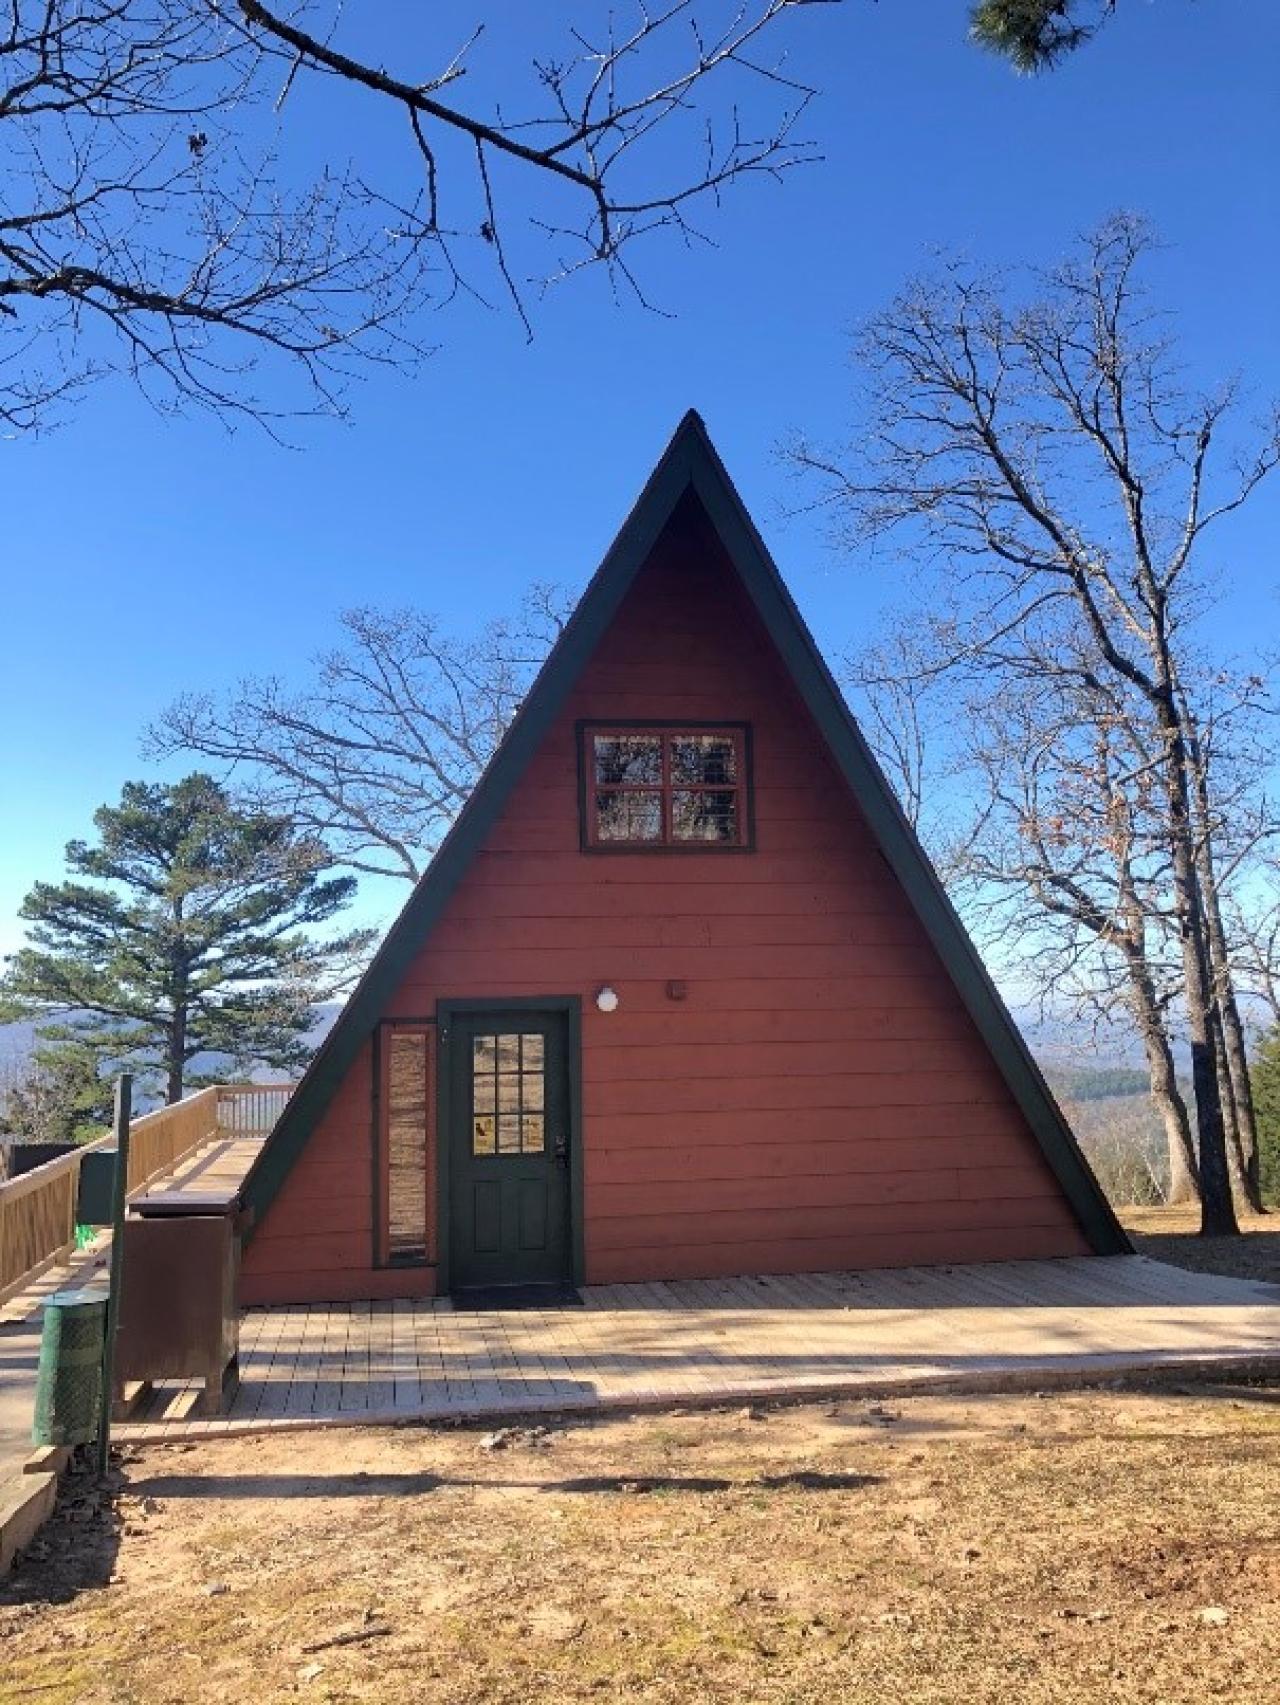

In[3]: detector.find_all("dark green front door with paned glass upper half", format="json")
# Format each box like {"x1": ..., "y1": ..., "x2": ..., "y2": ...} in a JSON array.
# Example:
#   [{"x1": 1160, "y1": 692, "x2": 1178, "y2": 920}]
[{"x1": 448, "y1": 1009, "x2": 571, "y2": 1291}]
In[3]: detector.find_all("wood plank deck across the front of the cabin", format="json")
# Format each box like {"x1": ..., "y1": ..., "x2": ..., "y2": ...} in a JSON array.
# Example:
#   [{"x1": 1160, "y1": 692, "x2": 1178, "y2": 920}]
[{"x1": 116, "y1": 1255, "x2": 1280, "y2": 1441}]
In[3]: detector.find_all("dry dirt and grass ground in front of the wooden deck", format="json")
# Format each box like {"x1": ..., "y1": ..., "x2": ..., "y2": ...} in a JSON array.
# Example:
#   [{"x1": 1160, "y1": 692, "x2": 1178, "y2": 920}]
[{"x1": 0, "y1": 1388, "x2": 1280, "y2": 1705}]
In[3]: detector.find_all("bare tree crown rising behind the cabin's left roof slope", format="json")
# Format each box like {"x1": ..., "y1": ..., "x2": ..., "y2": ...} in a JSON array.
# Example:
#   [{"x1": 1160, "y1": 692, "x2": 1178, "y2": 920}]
[{"x1": 147, "y1": 587, "x2": 568, "y2": 881}]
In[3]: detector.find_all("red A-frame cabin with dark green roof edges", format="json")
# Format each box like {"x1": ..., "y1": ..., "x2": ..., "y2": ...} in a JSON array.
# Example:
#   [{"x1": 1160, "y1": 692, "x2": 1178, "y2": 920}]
[{"x1": 242, "y1": 413, "x2": 1128, "y2": 1303}]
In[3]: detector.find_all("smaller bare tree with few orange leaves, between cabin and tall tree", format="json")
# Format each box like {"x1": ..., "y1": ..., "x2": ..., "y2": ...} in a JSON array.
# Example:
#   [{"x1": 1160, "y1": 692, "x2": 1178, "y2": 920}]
[{"x1": 852, "y1": 634, "x2": 1200, "y2": 1200}]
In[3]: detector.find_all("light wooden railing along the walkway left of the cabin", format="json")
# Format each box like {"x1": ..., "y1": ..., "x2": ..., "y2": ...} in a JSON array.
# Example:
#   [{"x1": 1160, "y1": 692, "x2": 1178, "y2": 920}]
[{"x1": 0, "y1": 1083, "x2": 293, "y2": 1303}]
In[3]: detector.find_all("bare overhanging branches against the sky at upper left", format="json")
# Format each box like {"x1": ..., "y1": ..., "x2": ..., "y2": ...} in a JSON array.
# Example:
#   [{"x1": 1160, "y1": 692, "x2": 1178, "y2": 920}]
[{"x1": 0, "y1": 0, "x2": 831, "y2": 430}]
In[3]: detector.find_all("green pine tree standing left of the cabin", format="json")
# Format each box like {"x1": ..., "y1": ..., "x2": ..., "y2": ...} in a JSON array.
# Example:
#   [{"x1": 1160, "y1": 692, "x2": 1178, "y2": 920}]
[{"x1": 0, "y1": 774, "x2": 373, "y2": 1101}]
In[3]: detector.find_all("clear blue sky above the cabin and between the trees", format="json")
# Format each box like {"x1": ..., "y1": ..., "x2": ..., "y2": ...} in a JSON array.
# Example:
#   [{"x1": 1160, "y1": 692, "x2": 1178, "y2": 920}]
[{"x1": 0, "y1": 0, "x2": 1280, "y2": 951}]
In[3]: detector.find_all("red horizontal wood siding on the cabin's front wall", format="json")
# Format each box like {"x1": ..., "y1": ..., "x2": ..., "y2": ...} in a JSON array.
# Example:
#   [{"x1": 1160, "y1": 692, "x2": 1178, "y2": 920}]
[{"x1": 245, "y1": 508, "x2": 1087, "y2": 1298}]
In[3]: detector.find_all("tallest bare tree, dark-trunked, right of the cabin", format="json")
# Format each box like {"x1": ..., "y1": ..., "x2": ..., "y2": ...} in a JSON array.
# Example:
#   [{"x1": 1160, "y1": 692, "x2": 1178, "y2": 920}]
[{"x1": 794, "y1": 217, "x2": 1280, "y2": 1231}]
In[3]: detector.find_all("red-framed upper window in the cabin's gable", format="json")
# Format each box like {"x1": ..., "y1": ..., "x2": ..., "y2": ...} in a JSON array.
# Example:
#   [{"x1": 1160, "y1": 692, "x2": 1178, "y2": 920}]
[{"x1": 581, "y1": 723, "x2": 750, "y2": 853}]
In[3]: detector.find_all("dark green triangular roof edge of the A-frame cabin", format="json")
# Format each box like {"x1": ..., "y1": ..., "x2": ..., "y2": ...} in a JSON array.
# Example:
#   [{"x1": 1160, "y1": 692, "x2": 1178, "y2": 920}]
[{"x1": 242, "y1": 409, "x2": 1130, "y2": 1253}]
